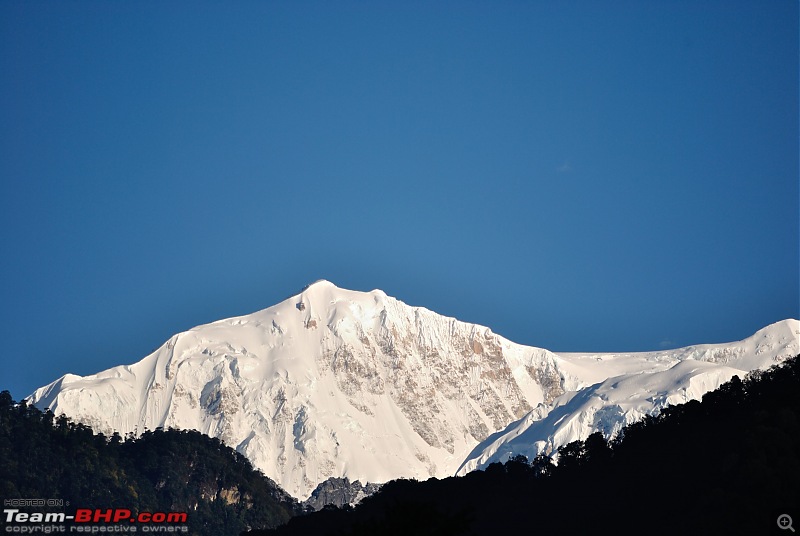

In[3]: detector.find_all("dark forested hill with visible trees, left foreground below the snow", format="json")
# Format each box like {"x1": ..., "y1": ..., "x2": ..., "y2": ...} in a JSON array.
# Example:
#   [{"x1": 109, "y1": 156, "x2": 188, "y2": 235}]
[{"x1": 0, "y1": 391, "x2": 299, "y2": 535}]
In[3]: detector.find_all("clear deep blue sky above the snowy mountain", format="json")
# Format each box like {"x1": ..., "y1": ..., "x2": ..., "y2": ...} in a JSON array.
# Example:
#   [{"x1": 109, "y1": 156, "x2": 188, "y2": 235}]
[{"x1": 0, "y1": 0, "x2": 800, "y2": 398}]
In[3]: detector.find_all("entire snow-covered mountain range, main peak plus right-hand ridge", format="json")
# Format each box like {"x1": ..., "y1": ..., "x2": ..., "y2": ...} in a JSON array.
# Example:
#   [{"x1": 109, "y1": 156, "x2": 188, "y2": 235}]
[{"x1": 30, "y1": 281, "x2": 800, "y2": 499}]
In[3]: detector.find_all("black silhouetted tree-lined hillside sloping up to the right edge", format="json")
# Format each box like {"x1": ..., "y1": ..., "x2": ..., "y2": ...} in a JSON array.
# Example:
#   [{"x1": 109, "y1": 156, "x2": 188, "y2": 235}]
[{"x1": 251, "y1": 357, "x2": 800, "y2": 536}]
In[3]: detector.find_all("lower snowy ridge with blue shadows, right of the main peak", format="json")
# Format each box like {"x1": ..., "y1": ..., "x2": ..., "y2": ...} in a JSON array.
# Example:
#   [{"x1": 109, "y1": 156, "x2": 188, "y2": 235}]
[{"x1": 457, "y1": 320, "x2": 800, "y2": 474}]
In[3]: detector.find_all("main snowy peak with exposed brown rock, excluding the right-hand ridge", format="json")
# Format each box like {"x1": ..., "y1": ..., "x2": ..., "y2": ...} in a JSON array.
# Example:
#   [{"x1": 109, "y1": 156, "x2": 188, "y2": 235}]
[{"x1": 31, "y1": 281, "x2": 561, "y2": 497}]
